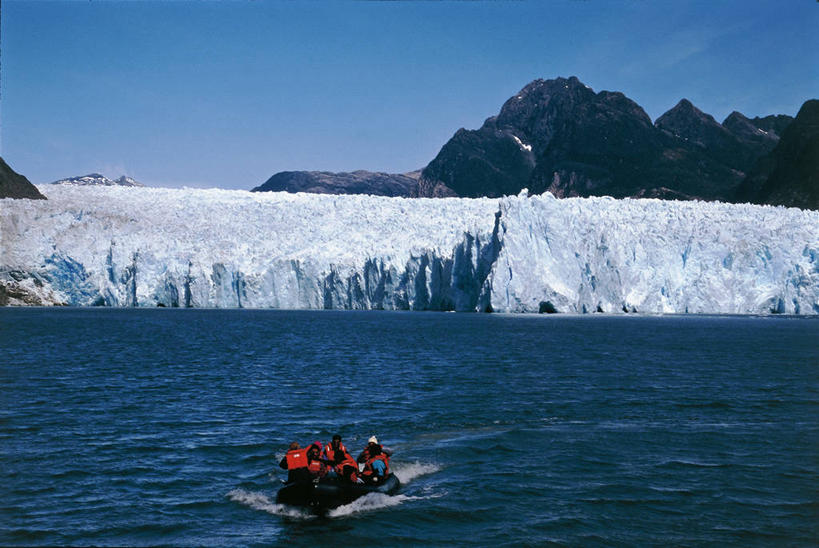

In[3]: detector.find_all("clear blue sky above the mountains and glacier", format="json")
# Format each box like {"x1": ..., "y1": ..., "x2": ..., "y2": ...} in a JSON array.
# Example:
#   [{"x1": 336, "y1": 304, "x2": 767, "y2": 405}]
[{"x1": 0, "y1": 0, "x2": 819, "y2": 189}]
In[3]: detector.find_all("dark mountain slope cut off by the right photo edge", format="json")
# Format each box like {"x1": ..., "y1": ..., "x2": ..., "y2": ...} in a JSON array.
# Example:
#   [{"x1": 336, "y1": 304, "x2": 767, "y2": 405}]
[{"x1": 736, "y1": 99, "x2": 819, "y2": 209}]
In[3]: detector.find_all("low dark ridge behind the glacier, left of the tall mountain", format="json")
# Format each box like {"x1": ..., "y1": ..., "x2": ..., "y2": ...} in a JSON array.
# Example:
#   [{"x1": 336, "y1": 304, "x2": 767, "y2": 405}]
[{"x1": 252, "y1": 171, "x2": 419, "y2": 196}]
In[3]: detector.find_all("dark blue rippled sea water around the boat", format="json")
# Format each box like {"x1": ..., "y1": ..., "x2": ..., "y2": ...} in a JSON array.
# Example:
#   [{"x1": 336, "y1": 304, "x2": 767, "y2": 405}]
[{"x1": 0, "y1": 308, "x2": 819, "y2": 546}]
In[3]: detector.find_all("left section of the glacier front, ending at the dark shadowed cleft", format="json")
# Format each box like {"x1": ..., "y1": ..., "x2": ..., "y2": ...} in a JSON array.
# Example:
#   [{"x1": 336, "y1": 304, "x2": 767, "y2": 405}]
[{"x1": 0, "y1": 185, "x2": 498, "y2": 310}]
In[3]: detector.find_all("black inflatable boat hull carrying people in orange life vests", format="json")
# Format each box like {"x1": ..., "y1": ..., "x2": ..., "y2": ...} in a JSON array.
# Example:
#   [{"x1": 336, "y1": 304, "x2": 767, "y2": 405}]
[{"x1": 276, "y1": 474, "x2": 401, "y2": 511}]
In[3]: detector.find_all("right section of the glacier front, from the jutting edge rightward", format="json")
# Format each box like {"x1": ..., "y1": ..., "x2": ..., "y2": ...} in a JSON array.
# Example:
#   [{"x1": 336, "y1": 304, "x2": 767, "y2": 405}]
[{"x1": 491, "y1": 194, "x2": 819, "y2": 314}]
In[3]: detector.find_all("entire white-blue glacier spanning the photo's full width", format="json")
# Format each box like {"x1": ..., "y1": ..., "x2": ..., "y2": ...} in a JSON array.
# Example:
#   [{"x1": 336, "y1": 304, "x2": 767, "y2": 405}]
[{"x1": 0, "y1": 185, "x2": 819, "y2": 315}]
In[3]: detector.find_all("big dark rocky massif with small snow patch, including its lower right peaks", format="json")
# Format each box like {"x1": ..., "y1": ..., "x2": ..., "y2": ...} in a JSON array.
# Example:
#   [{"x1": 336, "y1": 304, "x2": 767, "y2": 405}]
[{"x1": 420, "y1": 77, "x2": 796, "y2": 200}]
